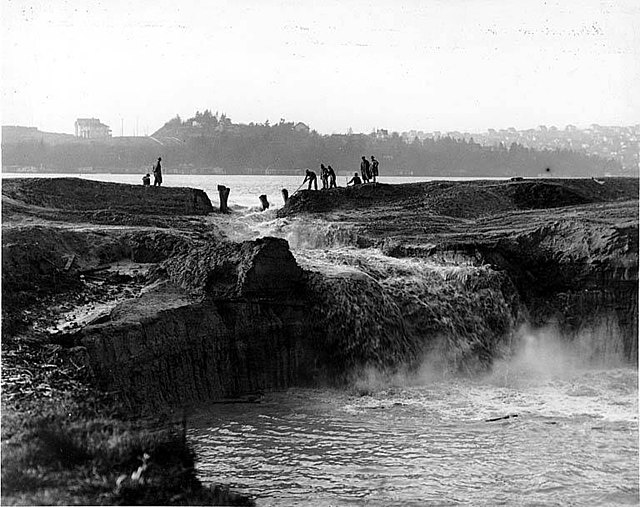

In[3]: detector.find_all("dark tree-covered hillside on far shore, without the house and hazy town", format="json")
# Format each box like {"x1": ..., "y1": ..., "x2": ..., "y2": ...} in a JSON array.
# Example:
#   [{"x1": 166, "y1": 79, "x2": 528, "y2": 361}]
[{"x1": 2, "y1": 110, "x2": 636, "y2": 177}]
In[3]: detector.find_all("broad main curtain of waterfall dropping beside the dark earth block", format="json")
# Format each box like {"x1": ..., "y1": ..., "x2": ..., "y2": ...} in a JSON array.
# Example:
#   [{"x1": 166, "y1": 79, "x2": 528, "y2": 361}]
[{"x1": 296, "y1": 248, "x2": 520, "y2": 378}]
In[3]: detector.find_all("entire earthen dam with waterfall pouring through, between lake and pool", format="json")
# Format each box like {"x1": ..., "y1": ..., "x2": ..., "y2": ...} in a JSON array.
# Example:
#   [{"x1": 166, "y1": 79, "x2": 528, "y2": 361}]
[{"x1": 2, "y1": 178, "x2": 638, "y2": 504}]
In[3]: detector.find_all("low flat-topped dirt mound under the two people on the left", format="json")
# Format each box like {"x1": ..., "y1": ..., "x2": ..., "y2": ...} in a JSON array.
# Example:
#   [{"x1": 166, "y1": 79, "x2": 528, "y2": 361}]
[{"x1": 2, "y1": 178, "x2": 213, "y2": 216}]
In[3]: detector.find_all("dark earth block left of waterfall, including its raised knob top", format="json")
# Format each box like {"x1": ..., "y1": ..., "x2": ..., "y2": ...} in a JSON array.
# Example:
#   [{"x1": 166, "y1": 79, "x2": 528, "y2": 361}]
[{"x1": 79, "y1": 238, "x2": 315, "y2": 405}]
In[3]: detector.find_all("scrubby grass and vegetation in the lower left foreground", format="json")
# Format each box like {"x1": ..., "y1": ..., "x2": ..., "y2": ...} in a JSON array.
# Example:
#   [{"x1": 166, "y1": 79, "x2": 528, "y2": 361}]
[{"x1": 2, "y1": 296, "x2": 253, "y2": 505}]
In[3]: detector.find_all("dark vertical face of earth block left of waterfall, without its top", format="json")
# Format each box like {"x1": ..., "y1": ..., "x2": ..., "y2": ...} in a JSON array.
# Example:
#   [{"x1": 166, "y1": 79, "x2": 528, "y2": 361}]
[{"x1": 80, "y1": 291, "x2": 312, "y2": 406}]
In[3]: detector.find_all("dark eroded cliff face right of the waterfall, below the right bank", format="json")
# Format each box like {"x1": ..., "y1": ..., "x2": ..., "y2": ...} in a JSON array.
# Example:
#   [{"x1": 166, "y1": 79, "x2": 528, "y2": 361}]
[{"x1": 467, "y1": 214, "x2": 638, "y2": 362}]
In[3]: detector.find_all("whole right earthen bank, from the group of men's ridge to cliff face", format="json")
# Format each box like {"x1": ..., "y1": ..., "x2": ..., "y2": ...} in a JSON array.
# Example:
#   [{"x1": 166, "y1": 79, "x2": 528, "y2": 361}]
[{"x1": 279, "y1": 178, "x2": 638, "y2": 362}]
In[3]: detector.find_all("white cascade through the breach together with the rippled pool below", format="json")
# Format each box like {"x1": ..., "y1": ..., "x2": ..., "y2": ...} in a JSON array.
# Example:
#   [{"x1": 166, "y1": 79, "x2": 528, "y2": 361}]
[{"x1": 188, "y1": 205, "x2": 640, "y2": 506}]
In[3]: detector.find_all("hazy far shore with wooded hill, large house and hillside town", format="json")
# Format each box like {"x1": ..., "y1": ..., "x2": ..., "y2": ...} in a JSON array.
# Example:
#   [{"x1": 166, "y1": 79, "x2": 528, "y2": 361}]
[{"x1": 2, "y1": 110, "x2": 640, "y2": 176}]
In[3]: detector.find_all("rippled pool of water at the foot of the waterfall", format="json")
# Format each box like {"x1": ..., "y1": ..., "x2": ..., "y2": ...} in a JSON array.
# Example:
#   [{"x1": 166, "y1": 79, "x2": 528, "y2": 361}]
[{"x1": 189, "y1": 369, "x2": 638, "y2": 506}]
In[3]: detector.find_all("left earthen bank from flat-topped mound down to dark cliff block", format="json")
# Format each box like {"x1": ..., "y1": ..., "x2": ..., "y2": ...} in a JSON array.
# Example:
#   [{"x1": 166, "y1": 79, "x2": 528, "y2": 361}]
[{"x1": 3, "y1": 179, "x2": 324, "y2": 406}]
